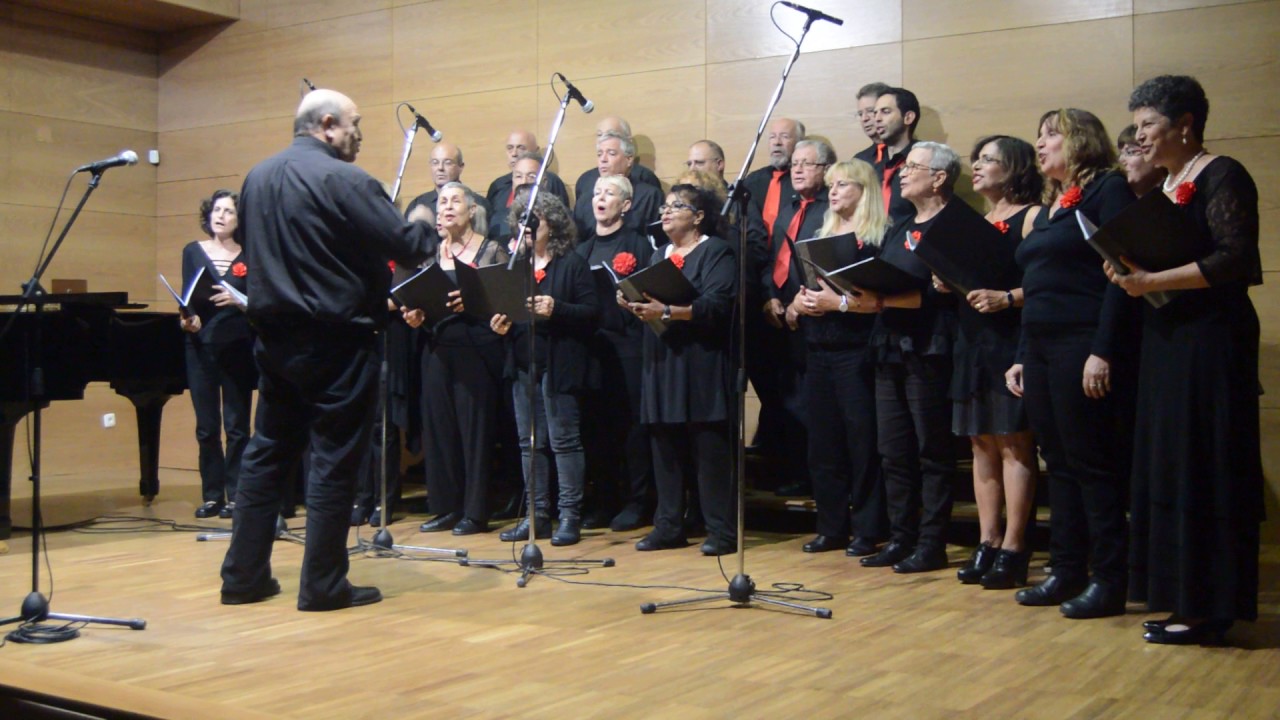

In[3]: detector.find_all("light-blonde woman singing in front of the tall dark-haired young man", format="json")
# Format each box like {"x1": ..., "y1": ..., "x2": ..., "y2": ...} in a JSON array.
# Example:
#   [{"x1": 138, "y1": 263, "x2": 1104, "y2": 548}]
[{"x1": 791, "y1": 160, "x2": 888, "y2": 556}]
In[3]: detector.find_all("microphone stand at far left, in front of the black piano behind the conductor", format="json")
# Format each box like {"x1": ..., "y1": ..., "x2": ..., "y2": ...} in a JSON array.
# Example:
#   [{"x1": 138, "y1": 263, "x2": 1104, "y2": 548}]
[{"x1": 0, "y1": 168, "x2": 147, "y2": 642}]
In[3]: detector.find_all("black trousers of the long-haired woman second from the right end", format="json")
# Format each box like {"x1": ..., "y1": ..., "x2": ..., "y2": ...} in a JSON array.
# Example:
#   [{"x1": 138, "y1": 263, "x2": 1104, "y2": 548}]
[{"x1": 1023, "y1": 325, "x2": 1128, "y2": 588}]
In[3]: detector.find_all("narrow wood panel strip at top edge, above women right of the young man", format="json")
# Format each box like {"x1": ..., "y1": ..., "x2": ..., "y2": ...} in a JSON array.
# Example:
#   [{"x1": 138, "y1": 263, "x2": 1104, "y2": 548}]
[{"x1": 902, "y1": 0, "x2": 1133, "y2": 39}]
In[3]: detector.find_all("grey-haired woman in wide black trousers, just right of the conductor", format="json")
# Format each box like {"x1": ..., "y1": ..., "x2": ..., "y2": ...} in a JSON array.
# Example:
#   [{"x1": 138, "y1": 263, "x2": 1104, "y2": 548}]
[{"x1": 404, "y1": 182, "x2": 508, "y2": 536}]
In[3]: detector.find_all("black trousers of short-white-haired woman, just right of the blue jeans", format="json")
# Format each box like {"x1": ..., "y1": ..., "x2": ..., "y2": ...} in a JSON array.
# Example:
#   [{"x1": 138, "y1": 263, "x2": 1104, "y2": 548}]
[{"x1": 582, "y1": 338, "x2": 654, "y2": 512}]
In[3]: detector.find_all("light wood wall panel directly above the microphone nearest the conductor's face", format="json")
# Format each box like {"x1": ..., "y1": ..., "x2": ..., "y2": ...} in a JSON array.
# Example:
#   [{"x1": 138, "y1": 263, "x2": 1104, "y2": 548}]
[{"x1": 392, "y1": 0, "x2": 532, "y2": 99}]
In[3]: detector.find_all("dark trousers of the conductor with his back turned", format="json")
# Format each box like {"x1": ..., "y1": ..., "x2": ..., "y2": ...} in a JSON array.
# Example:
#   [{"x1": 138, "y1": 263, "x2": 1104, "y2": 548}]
[{"x1": 223, "y1": 323, "x2": 378, "y2": 609}]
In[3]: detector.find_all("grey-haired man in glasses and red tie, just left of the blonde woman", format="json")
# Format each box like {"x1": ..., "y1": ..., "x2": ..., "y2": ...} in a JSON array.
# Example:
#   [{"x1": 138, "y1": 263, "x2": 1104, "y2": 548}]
[{"x1": 751, "y1": 140, "x2": 836, "y2": 495}]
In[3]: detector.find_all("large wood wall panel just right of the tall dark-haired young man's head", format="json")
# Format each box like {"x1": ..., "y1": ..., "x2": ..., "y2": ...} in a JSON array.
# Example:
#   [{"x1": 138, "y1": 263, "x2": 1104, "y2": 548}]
[{"x1": 902, "y1": 18, "x2": 1133, "y2": 156}]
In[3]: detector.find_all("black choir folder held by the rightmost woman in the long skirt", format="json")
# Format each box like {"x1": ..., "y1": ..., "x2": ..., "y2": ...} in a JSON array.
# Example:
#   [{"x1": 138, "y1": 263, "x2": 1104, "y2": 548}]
[{"x1": 1075, "y1": 191, "x2": 1203, "y2": 307}]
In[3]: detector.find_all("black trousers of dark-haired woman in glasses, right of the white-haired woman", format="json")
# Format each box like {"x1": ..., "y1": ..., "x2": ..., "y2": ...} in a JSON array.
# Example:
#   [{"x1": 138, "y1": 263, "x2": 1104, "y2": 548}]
[{"x1": 649, "y1": 421, "x2": 737, "y2": 543}]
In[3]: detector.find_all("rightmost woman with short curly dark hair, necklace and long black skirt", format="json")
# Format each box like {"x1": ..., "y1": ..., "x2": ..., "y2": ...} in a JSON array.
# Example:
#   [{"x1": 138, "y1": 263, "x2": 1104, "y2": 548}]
[{"x1": 1107, "y1": 76, "x2": 1263, "y2": 644}]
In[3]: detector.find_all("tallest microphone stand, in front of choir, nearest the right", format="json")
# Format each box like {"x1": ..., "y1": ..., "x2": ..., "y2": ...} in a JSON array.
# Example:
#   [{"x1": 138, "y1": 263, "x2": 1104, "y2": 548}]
[{"x1": 640, "y1": 15, "x2": 831, "y2": 619}]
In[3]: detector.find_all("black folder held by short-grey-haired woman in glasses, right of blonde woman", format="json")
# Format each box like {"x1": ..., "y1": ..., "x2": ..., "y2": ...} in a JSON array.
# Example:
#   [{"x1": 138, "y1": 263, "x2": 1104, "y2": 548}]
[{"x1": 911, "y1": 197, "x2": 1018, "y2": 297}]
